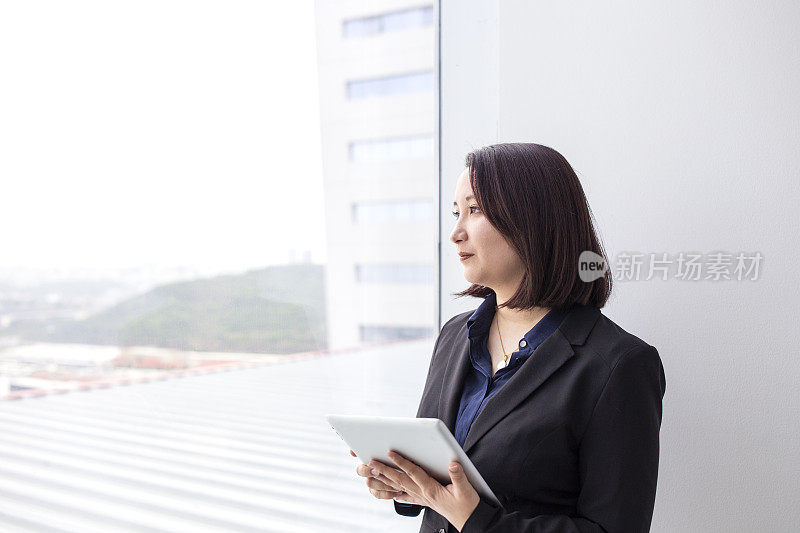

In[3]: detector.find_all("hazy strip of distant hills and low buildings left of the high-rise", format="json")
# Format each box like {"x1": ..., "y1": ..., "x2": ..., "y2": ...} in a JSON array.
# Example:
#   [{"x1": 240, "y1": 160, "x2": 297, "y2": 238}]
[{"x1": 0, "y1": 252, "x2": 326, "y2": 398}]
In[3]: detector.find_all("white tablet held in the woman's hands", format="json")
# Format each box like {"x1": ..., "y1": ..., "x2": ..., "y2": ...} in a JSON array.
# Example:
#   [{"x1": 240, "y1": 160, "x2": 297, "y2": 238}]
[{"x1": 325, "y1": 415, "x2": 502, "y2": 507}]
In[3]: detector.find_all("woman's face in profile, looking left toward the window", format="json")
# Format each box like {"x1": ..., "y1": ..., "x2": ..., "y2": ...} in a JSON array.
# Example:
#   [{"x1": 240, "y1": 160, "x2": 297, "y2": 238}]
[{"x1": 450, "y1": 168, "x2": 525, "y2": 293}]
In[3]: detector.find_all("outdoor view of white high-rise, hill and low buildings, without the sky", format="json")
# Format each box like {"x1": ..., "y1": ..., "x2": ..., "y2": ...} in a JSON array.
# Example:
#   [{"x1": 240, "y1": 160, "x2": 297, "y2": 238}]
[{"x1": 0, "y1": 2, "x2": 438, "y2": 398}]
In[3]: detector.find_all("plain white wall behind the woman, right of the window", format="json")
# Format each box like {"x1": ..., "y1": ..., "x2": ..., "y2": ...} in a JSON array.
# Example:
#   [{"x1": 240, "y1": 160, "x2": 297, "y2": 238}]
[{"x1": 440, "y1": 0, "x2": 800, "y2": 532}]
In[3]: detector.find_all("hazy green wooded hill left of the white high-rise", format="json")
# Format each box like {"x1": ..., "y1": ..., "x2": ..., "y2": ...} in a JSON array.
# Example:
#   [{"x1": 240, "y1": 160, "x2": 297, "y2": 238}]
[{"x1": 13, "y1": 264, "x2": 327, "y2": 353}]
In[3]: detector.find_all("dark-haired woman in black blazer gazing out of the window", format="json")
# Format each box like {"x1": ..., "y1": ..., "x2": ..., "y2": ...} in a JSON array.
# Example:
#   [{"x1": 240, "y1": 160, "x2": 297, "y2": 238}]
[{"x1": 351, "y1": 143, "x2": 666, "y2": 533}]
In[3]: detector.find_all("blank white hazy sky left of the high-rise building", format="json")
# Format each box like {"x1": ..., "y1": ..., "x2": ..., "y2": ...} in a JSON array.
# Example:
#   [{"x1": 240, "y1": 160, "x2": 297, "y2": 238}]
[{"x1": 0, "y1": 0, "x2": 325, "y2": 269}]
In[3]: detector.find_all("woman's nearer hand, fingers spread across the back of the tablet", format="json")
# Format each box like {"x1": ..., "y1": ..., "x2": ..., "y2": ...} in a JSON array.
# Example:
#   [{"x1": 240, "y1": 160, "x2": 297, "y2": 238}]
[{"x1": 368, "y1": 450, "x2": 480, "y2": 531}]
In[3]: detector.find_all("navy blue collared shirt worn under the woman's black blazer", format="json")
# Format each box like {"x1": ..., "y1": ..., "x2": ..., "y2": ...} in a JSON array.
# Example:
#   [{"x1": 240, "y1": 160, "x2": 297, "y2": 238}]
[{"x1": 455, "y1": 293, "x2": 567, "y2": 447}]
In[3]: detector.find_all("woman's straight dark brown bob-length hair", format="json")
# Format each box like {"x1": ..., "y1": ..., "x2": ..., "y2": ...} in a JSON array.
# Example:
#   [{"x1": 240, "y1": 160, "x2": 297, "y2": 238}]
[{"x1": 453, "y1": 143, "x2": 612, "y2": 309}]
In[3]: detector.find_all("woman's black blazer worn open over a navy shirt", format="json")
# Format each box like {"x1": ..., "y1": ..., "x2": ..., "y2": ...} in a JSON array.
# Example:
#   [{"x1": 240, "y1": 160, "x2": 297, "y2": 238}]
[{"x1": 395, "y1": 305, "x2": 666, "y2": 533}]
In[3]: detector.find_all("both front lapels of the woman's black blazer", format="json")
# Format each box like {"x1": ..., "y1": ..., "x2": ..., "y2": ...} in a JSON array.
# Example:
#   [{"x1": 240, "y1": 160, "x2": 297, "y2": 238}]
[{"x1": 439, "y1": 305, "x2": 600, "y2": 452}]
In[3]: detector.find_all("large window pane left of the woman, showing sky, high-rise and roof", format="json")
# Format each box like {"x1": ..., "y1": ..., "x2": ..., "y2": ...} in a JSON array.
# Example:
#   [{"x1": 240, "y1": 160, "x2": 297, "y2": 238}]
[{"x1": 0, "y1": 0, "x2": 438, "y2": 533}]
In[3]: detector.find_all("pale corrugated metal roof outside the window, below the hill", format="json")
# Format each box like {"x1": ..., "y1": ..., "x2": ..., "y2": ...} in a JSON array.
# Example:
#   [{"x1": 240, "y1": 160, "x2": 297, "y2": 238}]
[{"x1": 0, "y1": 339, "x2": 433, "y2": 533}]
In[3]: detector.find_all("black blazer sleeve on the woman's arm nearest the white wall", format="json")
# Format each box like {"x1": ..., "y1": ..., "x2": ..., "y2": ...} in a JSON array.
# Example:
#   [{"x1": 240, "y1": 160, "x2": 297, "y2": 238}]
[{"x1": 461, "y1": 345, "x2": 666, "y2": 533}]
